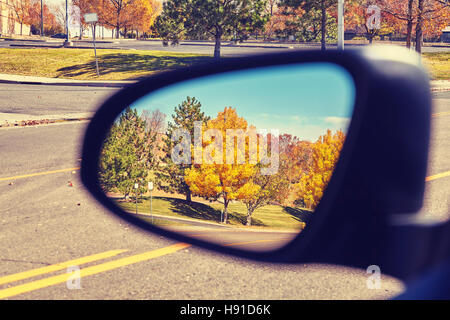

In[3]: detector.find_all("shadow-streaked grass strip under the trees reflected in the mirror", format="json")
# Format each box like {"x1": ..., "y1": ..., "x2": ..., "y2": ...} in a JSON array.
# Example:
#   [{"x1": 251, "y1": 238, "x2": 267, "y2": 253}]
[{"x1": 118, "y1": 197, "x2": 311, "y2": 230}]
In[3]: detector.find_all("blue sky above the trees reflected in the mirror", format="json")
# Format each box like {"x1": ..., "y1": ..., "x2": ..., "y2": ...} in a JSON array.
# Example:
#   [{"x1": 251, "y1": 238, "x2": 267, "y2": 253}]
[{"x1": 133, "y1": 63, "x2": 355, "y2": 141}]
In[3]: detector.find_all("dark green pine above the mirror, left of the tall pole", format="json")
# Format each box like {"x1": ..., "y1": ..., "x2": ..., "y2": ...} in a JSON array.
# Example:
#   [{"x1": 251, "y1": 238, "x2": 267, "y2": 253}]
[{"x1": 155, "y1": 0, "x2": 268, "y2": 58}]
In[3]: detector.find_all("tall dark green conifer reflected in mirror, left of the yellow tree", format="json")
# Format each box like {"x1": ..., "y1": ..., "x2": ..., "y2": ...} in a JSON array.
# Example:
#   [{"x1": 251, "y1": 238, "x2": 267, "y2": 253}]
[{"x1": 156, "y1": 97, "x2": 209, "y2": 202}]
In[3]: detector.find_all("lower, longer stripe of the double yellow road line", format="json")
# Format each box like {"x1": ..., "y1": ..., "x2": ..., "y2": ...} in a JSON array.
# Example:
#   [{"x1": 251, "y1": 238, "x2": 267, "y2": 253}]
[{"x1": 0, "y1": 243, "x2": 190, "y2": 299}]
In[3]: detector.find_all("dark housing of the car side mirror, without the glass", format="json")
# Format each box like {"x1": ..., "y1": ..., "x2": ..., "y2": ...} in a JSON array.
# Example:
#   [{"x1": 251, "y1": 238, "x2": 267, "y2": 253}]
[{"x1": 81, "y1": 49, "x2": 431, "y2": 273}]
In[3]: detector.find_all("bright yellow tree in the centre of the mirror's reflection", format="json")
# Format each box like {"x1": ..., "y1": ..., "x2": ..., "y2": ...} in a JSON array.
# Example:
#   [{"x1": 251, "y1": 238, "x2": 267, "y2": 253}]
[{"x1": 185, "y1": 107, "x2": 260, "y2": 223}]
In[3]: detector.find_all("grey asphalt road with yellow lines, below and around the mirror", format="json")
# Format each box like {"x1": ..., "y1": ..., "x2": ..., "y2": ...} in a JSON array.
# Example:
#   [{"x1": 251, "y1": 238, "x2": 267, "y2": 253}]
[{"x1": 0, "y1": 87, "x2": 450, "y2": 300}]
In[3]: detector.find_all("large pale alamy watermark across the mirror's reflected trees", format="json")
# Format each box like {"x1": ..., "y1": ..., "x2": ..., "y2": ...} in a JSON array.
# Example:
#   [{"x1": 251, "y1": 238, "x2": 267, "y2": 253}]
[{"x1": 171, "y1": 121, "x2": 280, "y2": 175}]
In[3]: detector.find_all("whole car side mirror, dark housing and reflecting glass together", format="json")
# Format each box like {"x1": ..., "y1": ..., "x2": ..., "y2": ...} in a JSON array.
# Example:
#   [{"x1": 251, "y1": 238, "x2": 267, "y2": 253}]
[{"x1": 81, "y1": 49, "x2": 431, "y2": 280}]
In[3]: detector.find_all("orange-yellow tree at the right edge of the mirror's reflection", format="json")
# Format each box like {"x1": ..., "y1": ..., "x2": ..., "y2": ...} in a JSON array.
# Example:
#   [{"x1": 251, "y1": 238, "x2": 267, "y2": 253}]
[{"x1": 296, "y1": 130, "x2": 345, "y2": 209}]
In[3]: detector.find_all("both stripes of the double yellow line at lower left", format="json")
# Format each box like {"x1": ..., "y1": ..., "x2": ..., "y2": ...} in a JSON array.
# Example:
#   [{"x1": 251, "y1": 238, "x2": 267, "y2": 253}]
[{"x1": 0, "y1": 243, "x2": 190, "y2": 299}]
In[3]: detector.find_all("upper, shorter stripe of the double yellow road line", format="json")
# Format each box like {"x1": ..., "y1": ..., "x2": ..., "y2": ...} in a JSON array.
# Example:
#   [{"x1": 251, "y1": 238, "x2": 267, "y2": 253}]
[{"x1": 0, "y1": 250, "x2": 128, "y2": 285}]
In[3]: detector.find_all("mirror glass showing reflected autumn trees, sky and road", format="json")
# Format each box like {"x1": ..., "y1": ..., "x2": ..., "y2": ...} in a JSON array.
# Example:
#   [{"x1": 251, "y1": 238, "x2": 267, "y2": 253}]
[{"x1": 99, "y1": 63, "x2": 355, "y2": 250}]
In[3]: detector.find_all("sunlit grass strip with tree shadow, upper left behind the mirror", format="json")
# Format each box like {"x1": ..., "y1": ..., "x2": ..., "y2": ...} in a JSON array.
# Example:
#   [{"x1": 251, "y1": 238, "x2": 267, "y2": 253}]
[{"x1": 0, "y1": 48, "x2": 212, "y2": 80}]
